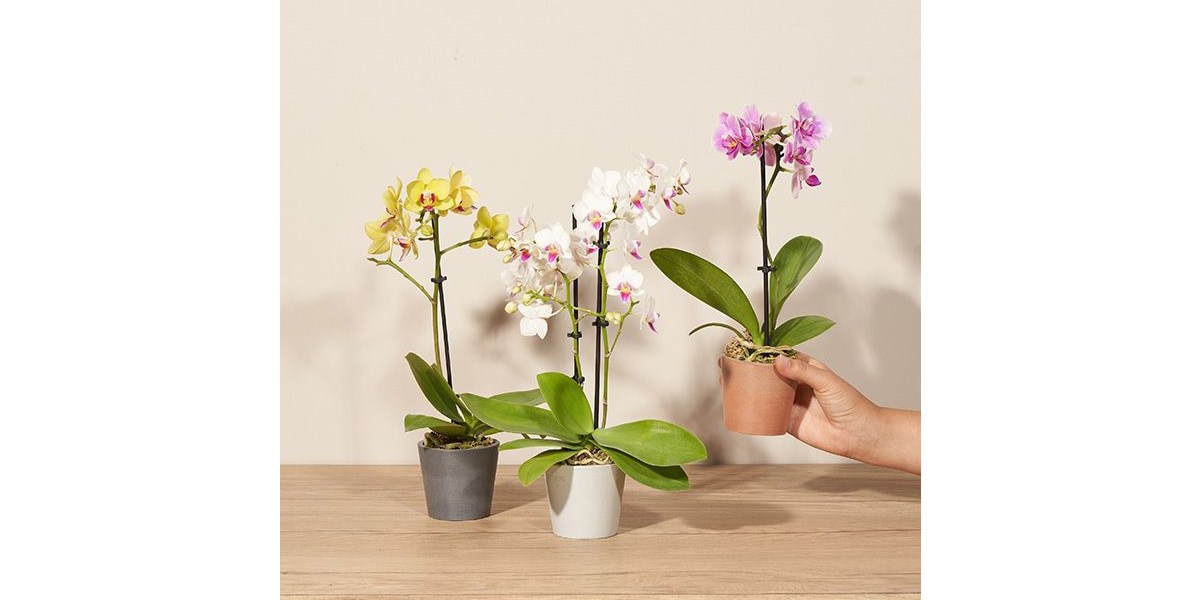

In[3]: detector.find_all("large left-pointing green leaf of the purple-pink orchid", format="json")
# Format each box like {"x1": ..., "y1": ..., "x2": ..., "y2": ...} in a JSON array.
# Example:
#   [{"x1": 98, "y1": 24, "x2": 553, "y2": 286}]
[{"x1": 650, "y1": 248, "x2": 762, "y2": 343}]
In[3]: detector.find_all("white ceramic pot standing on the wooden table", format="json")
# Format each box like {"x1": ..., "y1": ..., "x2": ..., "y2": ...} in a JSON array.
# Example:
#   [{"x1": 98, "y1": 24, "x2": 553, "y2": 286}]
[{"x1": 546, "y1": 464, "x2": 625, "y2": 540}]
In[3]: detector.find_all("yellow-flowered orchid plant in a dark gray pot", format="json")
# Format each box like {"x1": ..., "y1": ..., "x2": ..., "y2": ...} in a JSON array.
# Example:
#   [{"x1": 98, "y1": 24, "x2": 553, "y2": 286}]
[{"x1": 366, "y1": 168, "x2": 520, "y2": 521}]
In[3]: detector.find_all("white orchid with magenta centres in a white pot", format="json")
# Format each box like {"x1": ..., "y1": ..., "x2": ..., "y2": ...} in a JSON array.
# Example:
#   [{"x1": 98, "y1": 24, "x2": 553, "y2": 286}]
[{"x1": 462, "y1": 156, "x2": 708, "y2": 539}]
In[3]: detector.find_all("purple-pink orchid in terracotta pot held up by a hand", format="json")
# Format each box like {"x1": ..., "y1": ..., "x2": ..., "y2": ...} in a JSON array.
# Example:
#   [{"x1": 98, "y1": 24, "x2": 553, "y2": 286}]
[{"x1": 650, "y1": 102, "x2": 834, "y2": 436}]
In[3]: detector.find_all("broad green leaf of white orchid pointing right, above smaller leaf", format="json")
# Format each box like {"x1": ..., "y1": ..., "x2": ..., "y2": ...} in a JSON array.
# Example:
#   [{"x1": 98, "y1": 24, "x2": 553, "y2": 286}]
[{"x1": 592, "y1": 419, "x2": 708, "y2": 467}]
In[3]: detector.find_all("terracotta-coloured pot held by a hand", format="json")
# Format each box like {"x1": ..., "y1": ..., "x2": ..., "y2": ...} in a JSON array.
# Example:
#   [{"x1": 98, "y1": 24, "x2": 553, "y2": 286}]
[{"x1": 720, "y1": 356, "x2": 796, "y2": 436}]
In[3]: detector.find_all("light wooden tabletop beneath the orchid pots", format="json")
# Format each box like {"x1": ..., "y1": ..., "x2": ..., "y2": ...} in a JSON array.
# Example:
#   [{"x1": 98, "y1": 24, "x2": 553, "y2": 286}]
[{"x1": 280, "y1": 464, "x2": 920, "y2": 600}]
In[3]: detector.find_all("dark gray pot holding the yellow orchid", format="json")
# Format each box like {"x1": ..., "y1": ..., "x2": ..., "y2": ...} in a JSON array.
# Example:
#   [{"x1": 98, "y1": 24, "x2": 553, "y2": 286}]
[{"x1": 416, "y1": 439, "x2": 500, "y2": 521}]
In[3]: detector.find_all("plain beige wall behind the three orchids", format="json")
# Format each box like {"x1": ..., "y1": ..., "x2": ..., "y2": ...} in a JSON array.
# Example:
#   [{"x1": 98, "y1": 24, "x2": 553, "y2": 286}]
[{"x1": 280, "y1": 1, "x2": 920, "y2": 463}]
